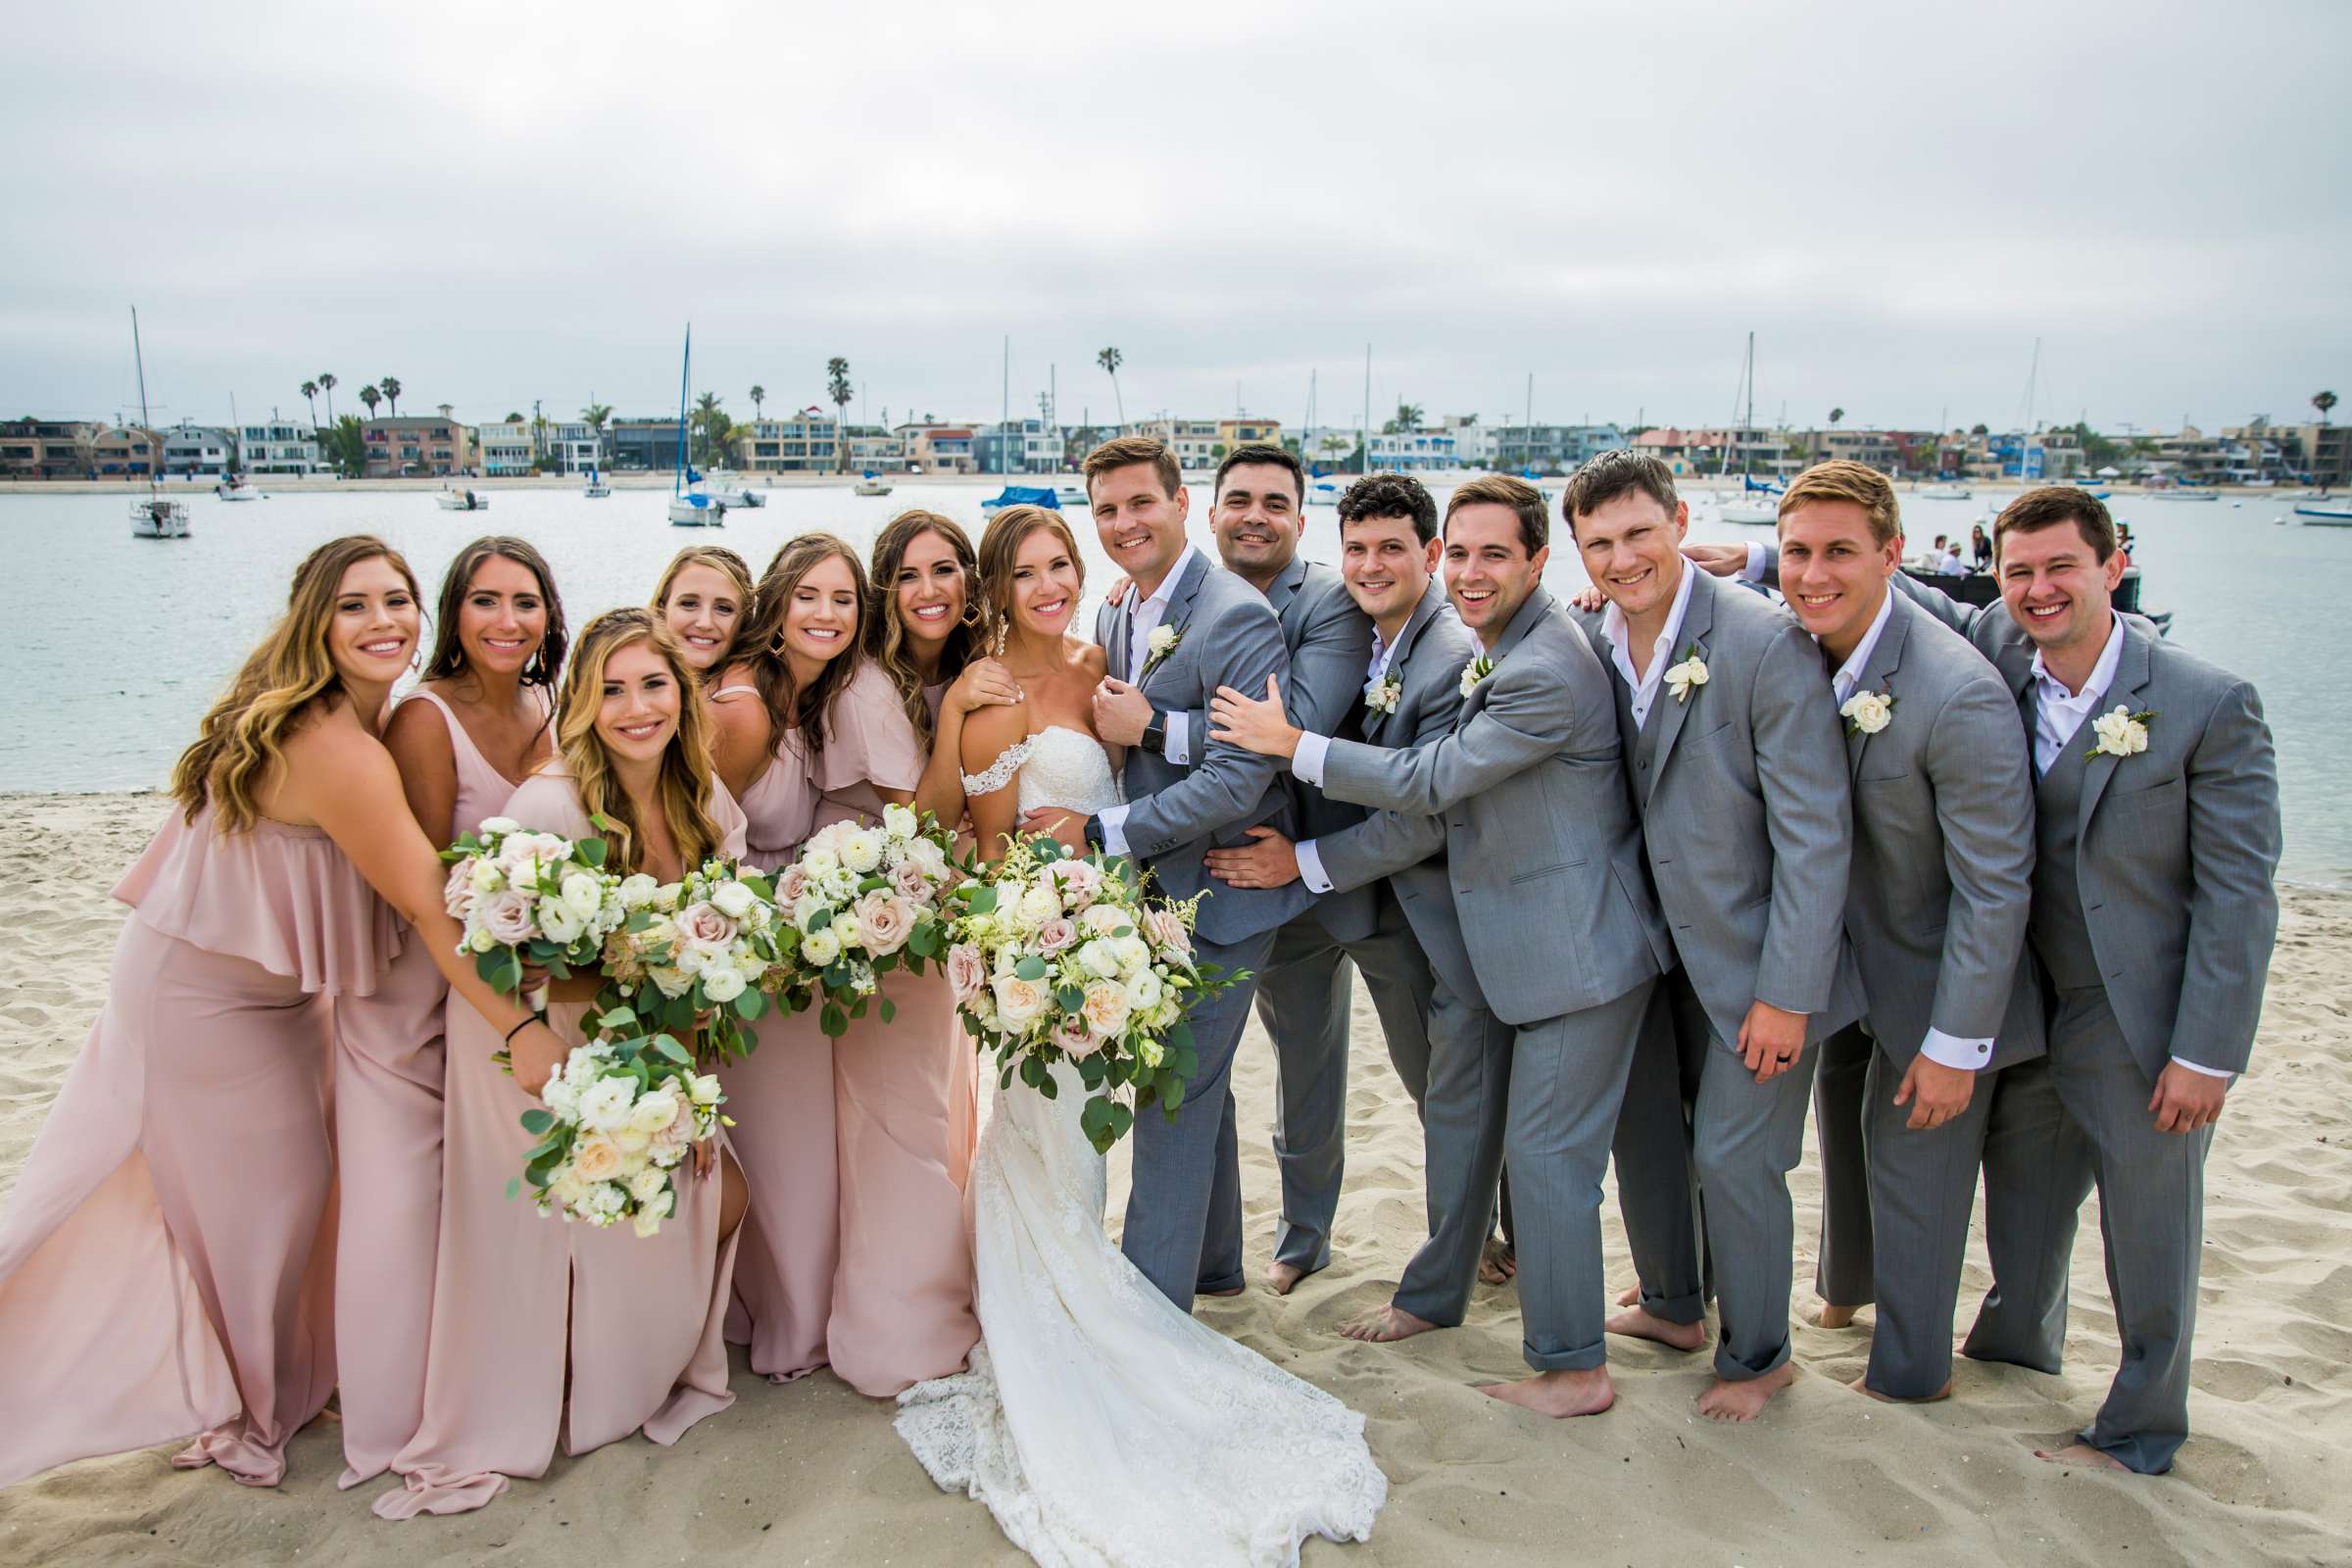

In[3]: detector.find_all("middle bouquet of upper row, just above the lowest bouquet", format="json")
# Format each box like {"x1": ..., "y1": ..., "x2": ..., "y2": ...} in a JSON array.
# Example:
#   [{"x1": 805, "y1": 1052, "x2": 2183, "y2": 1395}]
[{"x1": 598, "y1": 860, "x2": 800, "y2": 1057}]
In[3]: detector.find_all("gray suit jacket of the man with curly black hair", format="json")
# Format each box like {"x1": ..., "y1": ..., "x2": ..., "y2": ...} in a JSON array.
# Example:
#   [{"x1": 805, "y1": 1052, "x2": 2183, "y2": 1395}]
[{"x1": 1300, "y1": 578, "x2": 1480, "y2": 1002}]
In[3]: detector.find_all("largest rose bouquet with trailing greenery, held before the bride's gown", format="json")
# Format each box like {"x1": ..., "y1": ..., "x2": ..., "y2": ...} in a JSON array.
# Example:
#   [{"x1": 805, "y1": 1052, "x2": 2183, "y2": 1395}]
[{"x1": 948, "y1": 837, "x2": 1247, "y2": 1152}]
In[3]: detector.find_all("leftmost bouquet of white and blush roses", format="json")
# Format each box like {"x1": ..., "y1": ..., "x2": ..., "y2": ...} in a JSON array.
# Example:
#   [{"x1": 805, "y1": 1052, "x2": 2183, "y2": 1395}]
[{"x1": 442, "y1": 815, "x2": 623, "y2": 992}]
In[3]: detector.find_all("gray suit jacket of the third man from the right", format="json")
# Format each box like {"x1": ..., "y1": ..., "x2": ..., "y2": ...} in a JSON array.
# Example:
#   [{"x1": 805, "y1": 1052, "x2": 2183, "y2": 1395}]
[{"x1": 1583, "y1": 566, "x2": 1863, "y2": 1046}]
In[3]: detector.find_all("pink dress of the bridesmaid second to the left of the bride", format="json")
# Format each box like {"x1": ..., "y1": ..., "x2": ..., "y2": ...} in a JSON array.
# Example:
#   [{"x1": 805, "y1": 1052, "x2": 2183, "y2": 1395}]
[{"x1": 710, "y1": 686, "x2": 840, "y2": 1382}]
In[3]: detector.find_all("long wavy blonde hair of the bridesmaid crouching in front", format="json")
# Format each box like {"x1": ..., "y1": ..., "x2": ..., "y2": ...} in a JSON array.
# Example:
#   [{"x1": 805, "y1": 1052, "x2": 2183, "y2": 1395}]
[{"x1": 555, "y1": 609, "x2": 719, "y2": 872}]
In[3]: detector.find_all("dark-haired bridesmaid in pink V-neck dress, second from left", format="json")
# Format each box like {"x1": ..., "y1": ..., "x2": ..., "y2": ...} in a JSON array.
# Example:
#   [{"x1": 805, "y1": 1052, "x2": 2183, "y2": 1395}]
[{"x1": 334, "y1": 536, "x2": 564, "y2": 1486}]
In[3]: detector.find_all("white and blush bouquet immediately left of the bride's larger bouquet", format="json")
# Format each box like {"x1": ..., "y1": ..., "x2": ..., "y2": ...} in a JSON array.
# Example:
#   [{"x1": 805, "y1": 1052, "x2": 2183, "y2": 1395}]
[{"x1": 776, "y1": 807, "x2": 959, "y2": 1037}]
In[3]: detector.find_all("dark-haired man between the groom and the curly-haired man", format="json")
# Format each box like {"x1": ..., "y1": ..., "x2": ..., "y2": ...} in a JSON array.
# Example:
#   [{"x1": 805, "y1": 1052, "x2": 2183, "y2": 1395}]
[{"x1": 1094, "y1": 444, "x2": 1435, "y2": 1296}]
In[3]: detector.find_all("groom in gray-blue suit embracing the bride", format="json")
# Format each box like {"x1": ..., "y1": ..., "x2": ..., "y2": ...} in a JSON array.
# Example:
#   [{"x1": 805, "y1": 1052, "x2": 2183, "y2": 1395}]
[{"x1": 1021, "y1": 435, "x2": 1315, "y2": 1312}]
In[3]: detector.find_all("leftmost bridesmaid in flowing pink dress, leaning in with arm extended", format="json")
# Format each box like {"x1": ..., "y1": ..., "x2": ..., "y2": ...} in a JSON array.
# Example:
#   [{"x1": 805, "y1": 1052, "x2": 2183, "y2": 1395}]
[{"x1": 0, "y1": 536, "x2": 560, "y2": 1486}]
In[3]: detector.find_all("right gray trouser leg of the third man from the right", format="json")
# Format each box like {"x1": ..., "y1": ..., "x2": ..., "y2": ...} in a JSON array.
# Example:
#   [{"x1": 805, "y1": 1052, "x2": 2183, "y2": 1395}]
[{"x1": 1693, "y1": 1024, "x2": 1821, "y2": 1382}]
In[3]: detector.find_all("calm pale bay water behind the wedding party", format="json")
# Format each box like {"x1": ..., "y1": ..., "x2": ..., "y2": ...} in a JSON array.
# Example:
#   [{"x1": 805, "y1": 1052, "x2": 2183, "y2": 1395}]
[{"x1": 0, "y1": 482, "x2": 2352, "y2": 884}]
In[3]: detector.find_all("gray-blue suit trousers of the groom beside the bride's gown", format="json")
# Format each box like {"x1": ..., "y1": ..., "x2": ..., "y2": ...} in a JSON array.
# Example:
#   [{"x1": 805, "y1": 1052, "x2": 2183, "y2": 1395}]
[{"x1": 1119, "y1": 931, "x2": 1275, "y2": 1312}]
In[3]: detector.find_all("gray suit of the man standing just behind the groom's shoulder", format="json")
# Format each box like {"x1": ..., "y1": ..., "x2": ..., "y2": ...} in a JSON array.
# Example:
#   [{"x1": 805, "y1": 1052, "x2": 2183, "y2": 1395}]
[{"x1": 1186, "y1": 558, "x2": 1433, "y2": 1274}]
